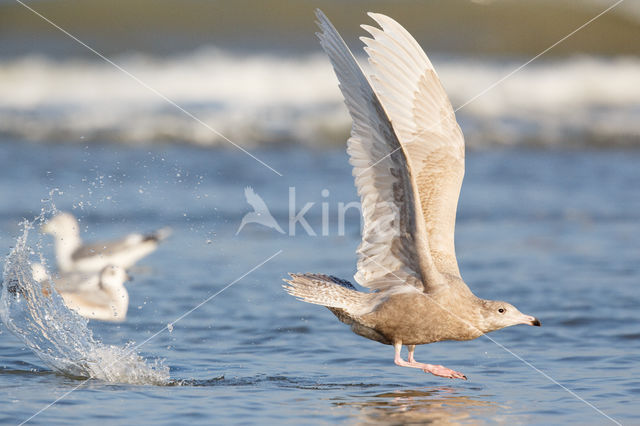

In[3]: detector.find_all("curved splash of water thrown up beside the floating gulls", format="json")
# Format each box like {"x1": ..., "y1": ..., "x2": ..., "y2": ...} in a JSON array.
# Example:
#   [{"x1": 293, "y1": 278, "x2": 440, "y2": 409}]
[{"x1": 0, "y1": 216, "x2": 169, "y2": 385}]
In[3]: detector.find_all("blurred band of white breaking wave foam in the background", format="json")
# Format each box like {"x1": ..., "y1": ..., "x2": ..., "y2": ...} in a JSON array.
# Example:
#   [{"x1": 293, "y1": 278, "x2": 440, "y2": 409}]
[{"x1": 0, "y1": 49, "x2": 640, "y2": 147}]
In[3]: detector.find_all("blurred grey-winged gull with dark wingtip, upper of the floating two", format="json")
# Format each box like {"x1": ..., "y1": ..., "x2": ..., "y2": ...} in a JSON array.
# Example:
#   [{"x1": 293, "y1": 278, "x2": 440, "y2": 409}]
[{"x1": 42, "y1": 213, "x2": 171, "y2": 273}]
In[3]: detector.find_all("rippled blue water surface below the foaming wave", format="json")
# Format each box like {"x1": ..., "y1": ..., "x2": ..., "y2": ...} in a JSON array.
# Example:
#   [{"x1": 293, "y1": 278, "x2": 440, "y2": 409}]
[{"x1": 0, "y1": 141, "x2": 640, "y2": 424}]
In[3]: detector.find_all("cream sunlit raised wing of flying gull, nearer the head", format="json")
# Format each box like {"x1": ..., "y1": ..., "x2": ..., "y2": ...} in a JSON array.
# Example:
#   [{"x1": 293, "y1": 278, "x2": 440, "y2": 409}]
[{"x1": 361, "y1": 13, "x2": 464, "y2": 276}]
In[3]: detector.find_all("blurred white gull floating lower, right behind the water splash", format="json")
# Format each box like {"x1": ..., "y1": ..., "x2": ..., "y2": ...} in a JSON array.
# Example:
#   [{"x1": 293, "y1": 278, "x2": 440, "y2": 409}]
[{"x1": 31, "y1": 263, "x2": 129, "y2": 322}]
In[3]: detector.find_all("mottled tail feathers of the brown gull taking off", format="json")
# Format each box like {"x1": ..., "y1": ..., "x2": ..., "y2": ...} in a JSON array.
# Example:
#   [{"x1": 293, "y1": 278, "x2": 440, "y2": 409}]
[{"x1": 282, "y1": 274, "x2": 375, "y2": 316}]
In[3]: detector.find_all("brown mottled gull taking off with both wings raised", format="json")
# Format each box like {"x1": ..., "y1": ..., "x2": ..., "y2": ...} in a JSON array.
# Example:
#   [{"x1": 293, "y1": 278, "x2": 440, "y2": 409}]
[{"x1": 285, "y1": 10, "x2": 540, "y2": 379}]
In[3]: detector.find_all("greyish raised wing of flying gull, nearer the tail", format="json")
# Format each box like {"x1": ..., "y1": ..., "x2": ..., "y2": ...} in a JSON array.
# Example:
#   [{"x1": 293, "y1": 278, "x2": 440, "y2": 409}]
[{"x1": 316, "y1": 10, "x2": 441, "y2": 290}]
